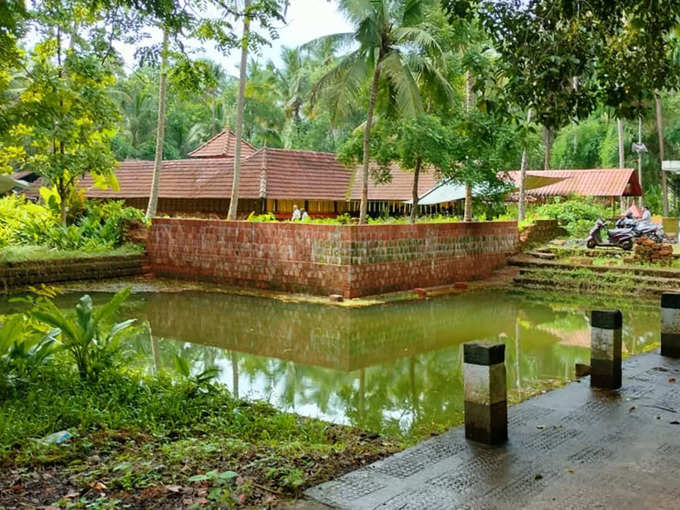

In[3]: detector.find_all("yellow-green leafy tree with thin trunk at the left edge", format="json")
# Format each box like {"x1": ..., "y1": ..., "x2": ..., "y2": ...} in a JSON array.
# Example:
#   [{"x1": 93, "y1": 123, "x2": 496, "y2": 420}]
[{"x1": 0, "y1": 39, "x2": 118, "y2": 225}]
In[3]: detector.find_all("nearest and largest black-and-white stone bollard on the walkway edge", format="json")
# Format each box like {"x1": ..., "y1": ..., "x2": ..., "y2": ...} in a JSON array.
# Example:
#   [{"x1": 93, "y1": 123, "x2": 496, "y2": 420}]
[{"x1": 463, "y1": 342, "x2": 508, "y2": 444}]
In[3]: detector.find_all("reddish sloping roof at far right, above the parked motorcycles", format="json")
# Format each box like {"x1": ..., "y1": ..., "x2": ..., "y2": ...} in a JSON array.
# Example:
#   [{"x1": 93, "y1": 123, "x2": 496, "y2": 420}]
[{"x1": 507, "y1": 168, "x2": 642, "y2": 197}]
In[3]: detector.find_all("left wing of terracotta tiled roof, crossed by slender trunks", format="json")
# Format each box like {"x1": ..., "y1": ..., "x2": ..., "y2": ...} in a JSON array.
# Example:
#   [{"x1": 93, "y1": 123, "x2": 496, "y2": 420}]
[{"x1": 79, "y1": 158, "x2": 260, "y2": 198}]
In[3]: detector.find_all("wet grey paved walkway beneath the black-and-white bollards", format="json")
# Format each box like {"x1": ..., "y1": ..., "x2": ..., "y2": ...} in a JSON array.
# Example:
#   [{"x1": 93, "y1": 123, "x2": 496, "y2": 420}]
[{"x1": 306, "y1": 354, "x2": 680, "y2": 510}]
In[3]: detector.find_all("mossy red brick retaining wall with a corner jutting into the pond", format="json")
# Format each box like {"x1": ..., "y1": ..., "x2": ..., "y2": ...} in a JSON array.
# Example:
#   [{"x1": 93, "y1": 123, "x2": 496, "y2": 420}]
[{"x1": 147, "y1": 218, "x2": 517, "y2": 297}]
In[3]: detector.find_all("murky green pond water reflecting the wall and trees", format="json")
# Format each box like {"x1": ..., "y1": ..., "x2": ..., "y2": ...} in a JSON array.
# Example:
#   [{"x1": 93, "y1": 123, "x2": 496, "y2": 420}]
[{"x1": 0, "y1": 290, "x2": 659, "y2": 433}]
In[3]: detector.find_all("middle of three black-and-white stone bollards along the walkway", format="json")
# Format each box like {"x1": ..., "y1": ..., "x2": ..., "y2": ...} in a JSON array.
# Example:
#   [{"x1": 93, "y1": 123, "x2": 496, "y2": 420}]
[{"x1": 590, "y1": 310, "x2": 623, "y2": 390}]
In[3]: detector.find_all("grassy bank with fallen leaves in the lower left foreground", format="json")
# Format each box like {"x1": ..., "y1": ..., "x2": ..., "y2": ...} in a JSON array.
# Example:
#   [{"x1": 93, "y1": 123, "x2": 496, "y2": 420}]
[{"x1": 0, "y1": 360, "x2": 402, "y2": 508}]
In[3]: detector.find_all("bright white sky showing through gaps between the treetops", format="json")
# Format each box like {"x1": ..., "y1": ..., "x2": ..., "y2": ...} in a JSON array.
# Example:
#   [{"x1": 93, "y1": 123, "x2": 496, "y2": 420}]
[{"x1": 117, "y1": 0, "x2": 351, "y2": 76}]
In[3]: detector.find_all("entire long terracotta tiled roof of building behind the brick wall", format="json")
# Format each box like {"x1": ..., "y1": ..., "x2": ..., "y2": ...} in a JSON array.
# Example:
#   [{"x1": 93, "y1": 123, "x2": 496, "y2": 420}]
[{"x1": 79, "y1": 148, "x2": 437, "y2": 201}]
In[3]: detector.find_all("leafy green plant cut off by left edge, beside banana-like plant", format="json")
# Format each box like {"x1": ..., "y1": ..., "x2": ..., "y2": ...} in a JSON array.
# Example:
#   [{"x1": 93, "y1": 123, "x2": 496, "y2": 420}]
[{"x1": 0, "y1": 315, "x2": 58, "y2": 401}]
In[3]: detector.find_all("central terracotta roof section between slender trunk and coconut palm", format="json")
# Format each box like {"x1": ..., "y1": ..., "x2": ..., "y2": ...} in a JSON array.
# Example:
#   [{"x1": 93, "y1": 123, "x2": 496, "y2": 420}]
[{"x1": 241, "y1": 148, "x2": 352, "y2": 201}]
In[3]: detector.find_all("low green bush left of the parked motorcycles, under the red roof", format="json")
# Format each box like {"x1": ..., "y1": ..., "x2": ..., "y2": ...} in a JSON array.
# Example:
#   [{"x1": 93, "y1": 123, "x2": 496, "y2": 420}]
[{"x1": 531, "y1": 198, "x2": 612, "y2": 238}]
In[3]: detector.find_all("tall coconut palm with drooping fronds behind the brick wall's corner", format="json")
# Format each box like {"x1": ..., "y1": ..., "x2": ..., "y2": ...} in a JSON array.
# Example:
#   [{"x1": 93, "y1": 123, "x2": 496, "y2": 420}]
[{"x1": 312, "y1": 0, "x2": 438, "y2": 223}]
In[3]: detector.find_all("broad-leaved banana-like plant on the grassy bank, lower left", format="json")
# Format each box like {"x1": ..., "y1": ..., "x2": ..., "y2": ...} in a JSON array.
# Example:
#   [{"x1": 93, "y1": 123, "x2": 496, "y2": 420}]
[{"x1": 29, "y1": 288, "x2": 135, "y2": 380}]
